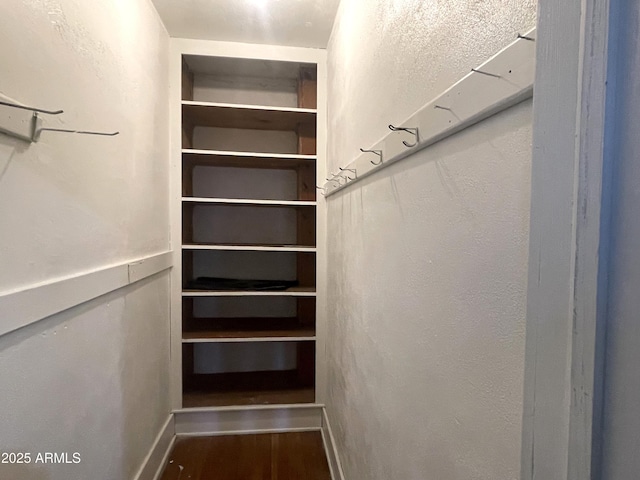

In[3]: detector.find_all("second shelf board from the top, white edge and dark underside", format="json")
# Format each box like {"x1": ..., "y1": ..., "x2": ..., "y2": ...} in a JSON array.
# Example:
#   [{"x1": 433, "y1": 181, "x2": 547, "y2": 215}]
[{"x1": 182, "y1": 148, "x2": 318, "y2": 169}]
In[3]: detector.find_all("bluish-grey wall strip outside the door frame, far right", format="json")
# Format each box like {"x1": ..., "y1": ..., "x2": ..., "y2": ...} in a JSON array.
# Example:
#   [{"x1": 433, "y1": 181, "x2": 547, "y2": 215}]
[{"x1": 602, "y1": 1, "x2": 640, "y2": 480}]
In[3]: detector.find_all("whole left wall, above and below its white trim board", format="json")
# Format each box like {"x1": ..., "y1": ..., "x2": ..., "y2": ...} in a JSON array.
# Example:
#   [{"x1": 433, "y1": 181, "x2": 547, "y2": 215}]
[{"x1": 0, "y1": 0, "x2": 170, "y2": 480}]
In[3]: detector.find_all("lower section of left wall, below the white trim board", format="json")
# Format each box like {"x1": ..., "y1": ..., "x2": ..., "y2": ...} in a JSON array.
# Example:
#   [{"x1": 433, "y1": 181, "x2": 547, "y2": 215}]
[{"x1": 0, "y1": 273, "x2": 170, "y2": 480}]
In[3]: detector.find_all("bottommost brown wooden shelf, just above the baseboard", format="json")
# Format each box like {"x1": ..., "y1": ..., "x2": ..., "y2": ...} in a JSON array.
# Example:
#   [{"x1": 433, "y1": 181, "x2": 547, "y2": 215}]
[{"x1": 182, "y1": 370, "x2": 315, "y2": 408}]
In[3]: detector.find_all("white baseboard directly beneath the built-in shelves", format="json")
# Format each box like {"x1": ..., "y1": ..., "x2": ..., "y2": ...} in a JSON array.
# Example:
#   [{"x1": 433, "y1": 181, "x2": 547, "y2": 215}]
[{"x1": 174, "y1": 404, "x2": 323, "y2": 436}]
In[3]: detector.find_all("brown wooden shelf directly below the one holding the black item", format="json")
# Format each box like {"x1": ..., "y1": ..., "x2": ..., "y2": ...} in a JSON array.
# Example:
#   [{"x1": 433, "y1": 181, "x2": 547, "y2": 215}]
[{"x1": 182, "y1": 317, "x2": 316, "y2": 343}]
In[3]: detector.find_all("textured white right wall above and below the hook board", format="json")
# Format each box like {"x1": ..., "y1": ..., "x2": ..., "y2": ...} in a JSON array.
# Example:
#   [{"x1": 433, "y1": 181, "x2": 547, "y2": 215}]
[{"x1": 321, "y1": 0, "x2": 536, "y2": 480}]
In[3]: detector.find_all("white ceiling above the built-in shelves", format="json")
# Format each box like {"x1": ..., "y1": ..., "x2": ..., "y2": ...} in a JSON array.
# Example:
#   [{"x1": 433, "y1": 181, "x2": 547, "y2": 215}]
[{"x1": 152, "y1": 0, "x2": 340, "y2": 48}]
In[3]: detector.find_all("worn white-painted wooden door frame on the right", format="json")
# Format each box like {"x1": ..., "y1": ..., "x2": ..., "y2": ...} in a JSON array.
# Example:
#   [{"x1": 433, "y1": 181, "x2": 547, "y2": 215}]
[{"x1": 521, "y1": 0, "x2": 617, "y2": 480}]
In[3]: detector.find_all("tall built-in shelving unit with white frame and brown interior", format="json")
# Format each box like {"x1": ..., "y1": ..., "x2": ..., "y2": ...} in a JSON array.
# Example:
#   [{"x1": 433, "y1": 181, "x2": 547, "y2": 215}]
[{"x1": 171, "y1": 40, "x2": 326, "y2": 412}]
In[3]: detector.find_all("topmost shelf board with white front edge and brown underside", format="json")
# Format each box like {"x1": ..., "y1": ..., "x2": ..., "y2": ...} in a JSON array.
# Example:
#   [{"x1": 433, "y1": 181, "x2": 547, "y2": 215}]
[{"x1": 182, "y1": 100, "x2": 317, "y2": 130}]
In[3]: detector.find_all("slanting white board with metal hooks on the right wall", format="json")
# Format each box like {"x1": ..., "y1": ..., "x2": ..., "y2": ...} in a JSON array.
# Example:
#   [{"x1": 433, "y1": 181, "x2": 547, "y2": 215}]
[{"x1": 323, "y1": 28, "x2": 536, "y2": 197}]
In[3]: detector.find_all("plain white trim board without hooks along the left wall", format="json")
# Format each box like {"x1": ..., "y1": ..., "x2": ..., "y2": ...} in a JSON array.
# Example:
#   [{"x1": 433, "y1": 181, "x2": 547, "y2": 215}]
[{"x1": 0, "y1": 251, "x2": 172, "y2": 336}]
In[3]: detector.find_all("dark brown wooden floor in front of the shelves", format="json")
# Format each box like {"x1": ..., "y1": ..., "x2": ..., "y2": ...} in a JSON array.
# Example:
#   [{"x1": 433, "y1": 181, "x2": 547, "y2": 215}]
[{"x1": 161, "y1": 432, "x2": 331, "y2": 480}]
